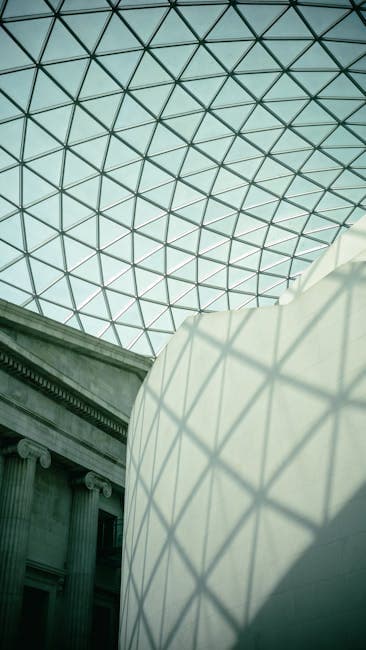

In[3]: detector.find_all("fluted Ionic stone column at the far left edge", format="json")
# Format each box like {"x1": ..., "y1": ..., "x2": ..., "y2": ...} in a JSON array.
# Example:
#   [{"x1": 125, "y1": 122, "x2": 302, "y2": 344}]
[{"x1": 0, "y1": 438, "x2": 51, "y2": 650}]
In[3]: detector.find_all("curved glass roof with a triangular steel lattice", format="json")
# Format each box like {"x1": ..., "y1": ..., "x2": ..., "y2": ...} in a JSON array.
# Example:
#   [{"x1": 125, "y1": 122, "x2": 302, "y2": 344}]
[{"x1": 0, "y1": 0, "x2": 366, "y2": 355}]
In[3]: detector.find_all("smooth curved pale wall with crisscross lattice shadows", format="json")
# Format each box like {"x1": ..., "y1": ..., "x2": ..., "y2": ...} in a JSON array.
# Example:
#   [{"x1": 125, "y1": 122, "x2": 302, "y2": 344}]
[{"x1": 120, "y1": 232, "x2": 366, "y2": 650}]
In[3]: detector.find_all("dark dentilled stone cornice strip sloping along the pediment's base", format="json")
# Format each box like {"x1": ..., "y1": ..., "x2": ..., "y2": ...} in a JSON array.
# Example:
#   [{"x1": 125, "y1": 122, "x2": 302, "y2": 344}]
[{"x1": 0, "y1": 332, "x2": 127, "y2": 441}]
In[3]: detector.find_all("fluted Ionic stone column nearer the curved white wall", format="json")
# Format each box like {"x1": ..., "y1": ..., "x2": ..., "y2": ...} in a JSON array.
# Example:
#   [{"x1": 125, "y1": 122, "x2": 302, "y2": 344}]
[{"x1": 64, "y1": 472, "x2": 112, "y2": 650}]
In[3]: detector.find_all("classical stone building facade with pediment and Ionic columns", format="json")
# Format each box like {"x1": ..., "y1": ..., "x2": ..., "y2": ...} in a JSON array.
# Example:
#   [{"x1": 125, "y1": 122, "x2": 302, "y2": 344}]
[{"x1": 0, "y1": 301, "x2": 151, "y2": 650}]
